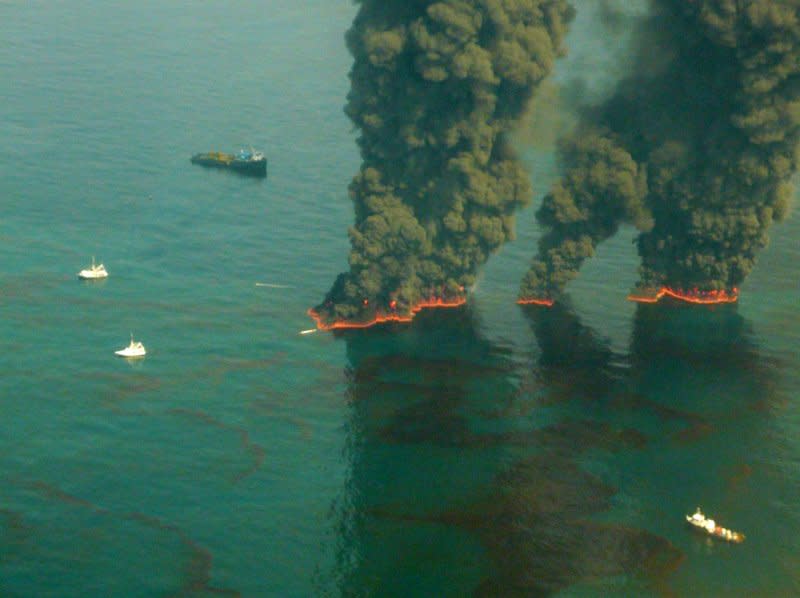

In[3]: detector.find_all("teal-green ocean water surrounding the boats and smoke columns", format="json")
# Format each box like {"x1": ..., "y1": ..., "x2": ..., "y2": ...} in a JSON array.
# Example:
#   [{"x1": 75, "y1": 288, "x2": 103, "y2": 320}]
[{"x1": 0, "y1": 0, "x2": 800, "y2": 597}]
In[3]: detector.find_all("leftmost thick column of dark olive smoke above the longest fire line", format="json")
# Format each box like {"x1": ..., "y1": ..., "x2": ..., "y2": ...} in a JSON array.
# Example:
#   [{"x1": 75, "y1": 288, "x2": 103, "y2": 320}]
[{"x1": 313, "y1": 0, "x2": 573, "y2": 326}]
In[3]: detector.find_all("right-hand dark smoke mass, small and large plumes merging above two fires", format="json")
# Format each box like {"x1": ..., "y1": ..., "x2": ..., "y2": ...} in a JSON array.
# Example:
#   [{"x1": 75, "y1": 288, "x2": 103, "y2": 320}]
[{"x1": 520, "y1": 0, "x2": 800, "y2": 300}]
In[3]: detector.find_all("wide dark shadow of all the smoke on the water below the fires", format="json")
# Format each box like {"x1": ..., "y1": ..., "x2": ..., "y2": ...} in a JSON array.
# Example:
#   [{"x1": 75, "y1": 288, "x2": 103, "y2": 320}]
[{"x1": 318, "y1": 301, "x2": 788, "y2": 596}]
